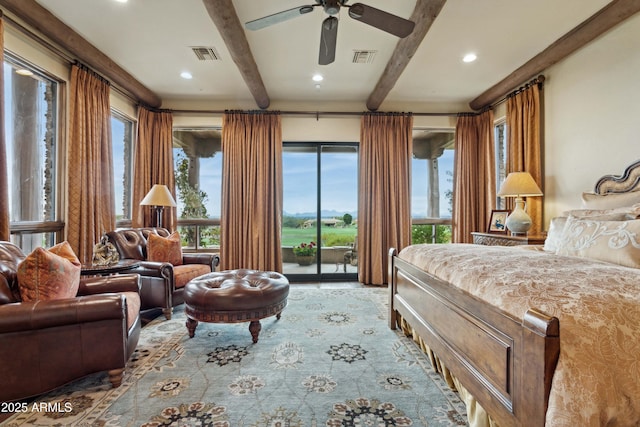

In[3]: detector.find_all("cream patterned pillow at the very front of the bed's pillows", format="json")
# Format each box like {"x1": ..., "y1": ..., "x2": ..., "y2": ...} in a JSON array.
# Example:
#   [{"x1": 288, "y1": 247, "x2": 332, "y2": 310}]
[{"x1": 556, "y1": 217, "x2": 640, "y2": 268}]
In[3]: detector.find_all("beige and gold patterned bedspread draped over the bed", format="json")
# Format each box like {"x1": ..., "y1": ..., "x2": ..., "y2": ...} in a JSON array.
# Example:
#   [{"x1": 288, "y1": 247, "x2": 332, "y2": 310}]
[{"x1": 399, "y1": 244, "x2": 640, "y2": 427}]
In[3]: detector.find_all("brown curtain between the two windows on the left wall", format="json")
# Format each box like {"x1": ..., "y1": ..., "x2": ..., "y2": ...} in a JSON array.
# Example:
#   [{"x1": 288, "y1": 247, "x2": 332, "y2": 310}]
[{"x1": 67, "y1": 65, "x2": 116, "y2": 262}]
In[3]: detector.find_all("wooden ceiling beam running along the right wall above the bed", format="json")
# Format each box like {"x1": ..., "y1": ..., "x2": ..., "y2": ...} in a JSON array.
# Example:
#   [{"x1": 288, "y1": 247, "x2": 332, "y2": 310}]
[{"x1": 469, "y1": 0, "x2": 640, "y2": 110}]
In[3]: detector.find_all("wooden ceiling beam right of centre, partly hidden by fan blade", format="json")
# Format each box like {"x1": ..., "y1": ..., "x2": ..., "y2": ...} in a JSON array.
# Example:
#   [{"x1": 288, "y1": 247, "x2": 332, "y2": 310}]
[{"x1": 367, "y1": 0, "x2": 446, "y2": 111}]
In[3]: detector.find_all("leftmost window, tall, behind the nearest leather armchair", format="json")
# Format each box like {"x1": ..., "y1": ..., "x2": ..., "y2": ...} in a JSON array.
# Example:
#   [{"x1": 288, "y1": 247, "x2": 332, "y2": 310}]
[{"x1": 3, "y1": 54, "x2": 64, "y2": 253}]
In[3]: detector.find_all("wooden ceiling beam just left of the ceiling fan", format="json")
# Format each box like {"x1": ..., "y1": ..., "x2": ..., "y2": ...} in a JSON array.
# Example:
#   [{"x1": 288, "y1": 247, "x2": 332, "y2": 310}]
[{"x1": 202, "y1": 0, "x2": 271, "y2": 109}]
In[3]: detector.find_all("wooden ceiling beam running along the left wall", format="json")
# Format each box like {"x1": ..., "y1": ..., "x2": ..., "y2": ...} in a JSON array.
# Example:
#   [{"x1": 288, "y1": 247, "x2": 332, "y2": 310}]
[{"x1": 0, "y1": 0, "x2": 162, "y2": 108}]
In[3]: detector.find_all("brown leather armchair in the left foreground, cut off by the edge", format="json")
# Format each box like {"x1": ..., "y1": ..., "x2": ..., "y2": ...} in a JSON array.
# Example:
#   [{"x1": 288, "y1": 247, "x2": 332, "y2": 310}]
[{"x1": 0, "y1": 241, "x2": 140, "y2": 401}]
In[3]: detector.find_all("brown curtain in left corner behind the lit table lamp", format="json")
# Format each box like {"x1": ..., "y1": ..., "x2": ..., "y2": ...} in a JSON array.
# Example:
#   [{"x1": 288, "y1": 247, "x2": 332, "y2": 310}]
[{"x1": 131, "y1": 107, "x2": 177, "y2": 231}]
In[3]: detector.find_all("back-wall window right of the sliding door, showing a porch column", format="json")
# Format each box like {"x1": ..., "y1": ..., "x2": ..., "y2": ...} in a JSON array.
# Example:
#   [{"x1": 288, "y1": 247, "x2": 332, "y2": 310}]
[{"x1": 411, "y1": 130, "x2": 455, "y2": 243}]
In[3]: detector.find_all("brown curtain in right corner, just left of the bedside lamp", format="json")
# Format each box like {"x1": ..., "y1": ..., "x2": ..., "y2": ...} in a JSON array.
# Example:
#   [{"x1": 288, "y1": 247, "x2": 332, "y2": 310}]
[{"x1": 452, "y1": 110, "x2": 496, "y2": 243}]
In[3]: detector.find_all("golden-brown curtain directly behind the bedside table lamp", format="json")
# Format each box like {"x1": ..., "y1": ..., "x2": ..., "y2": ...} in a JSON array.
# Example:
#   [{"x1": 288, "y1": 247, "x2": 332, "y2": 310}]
[{"x1": 507, "y1": 80, "x2": 544, "y2": 235}]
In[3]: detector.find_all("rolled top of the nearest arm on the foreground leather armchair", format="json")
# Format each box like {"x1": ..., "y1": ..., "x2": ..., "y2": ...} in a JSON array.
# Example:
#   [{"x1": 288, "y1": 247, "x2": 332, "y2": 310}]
[{"x1": 0, "y1": 294, "x2": 127, "y2": 334}]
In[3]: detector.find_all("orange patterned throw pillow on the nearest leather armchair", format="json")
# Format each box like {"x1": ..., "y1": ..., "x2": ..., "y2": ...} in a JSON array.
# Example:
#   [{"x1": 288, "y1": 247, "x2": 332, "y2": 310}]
[{"x1": 18, "y1": 242, "x2": 81, "y2": 302}]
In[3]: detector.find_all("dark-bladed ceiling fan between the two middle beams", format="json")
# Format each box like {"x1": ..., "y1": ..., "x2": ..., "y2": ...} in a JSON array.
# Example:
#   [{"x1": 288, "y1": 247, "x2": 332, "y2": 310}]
[{"x1": 245, "y1": 0, "x2": 415, "y2": 65}]
